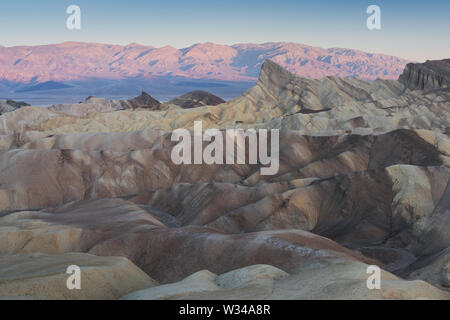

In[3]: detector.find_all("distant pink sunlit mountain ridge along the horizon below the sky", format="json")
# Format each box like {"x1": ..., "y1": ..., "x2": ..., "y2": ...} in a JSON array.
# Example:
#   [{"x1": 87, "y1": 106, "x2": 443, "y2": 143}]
[{"x1": 0, "y1": 42, "x2": 409, "y2": 84}]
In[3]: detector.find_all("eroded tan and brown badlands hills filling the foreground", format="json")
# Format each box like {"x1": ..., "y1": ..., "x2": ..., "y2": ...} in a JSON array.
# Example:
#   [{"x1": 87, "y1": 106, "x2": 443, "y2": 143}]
[{"x1": 0, "y1": 59, "x2": 450, "y2": 299}]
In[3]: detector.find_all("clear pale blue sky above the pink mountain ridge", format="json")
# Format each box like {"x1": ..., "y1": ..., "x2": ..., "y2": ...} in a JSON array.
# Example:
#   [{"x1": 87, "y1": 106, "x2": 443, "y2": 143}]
[{"x1": 0, "y1": 0, "x2": 450, "y2": 62}]
